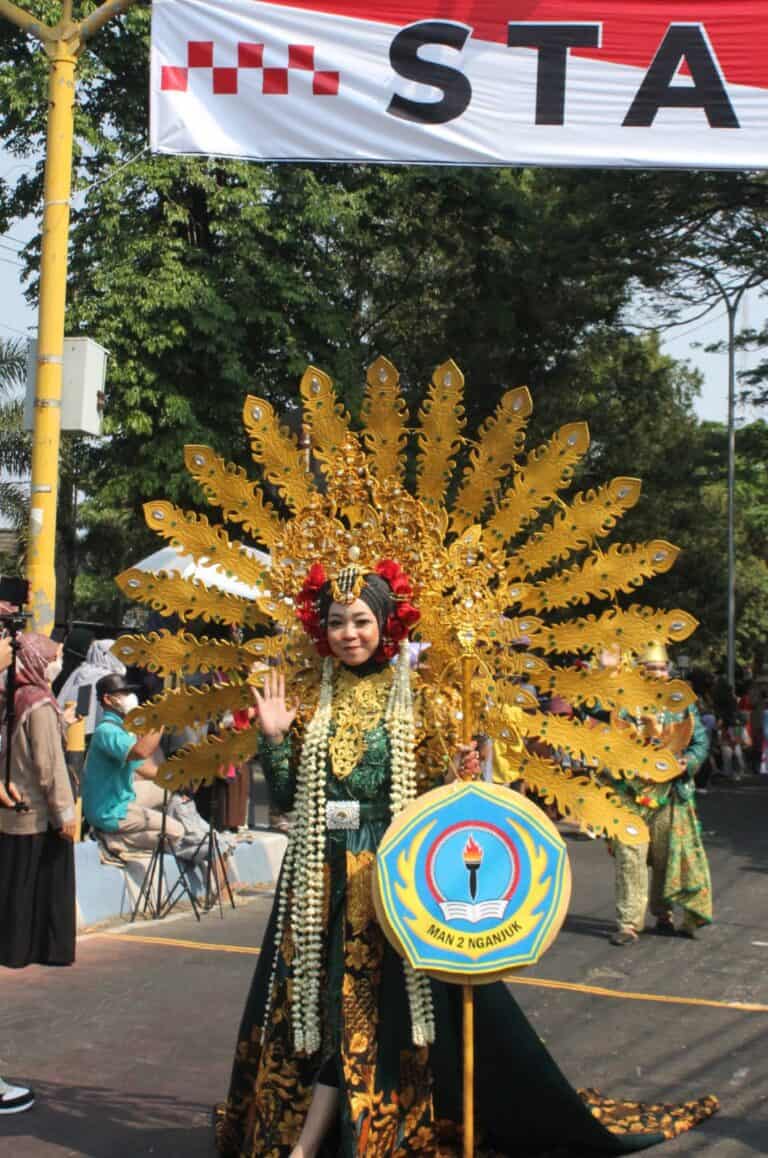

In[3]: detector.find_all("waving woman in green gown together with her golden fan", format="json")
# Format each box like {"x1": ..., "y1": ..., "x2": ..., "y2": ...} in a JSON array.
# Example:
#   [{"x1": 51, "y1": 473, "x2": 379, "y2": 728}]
[{"x1": 115, "y1": 358, "x2": 716, "y2": 1158}]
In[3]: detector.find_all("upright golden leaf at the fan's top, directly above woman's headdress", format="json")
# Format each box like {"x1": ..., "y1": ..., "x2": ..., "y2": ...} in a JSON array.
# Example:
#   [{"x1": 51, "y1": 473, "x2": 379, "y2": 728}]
[{"x1": 361, "y1": 358, "x2": 408, "y2": 483}]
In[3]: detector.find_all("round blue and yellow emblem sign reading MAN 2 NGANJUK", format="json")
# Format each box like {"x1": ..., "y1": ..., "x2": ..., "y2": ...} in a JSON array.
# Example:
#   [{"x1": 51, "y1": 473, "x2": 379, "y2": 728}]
[{"x1": 374, "y1": 782, "x2": 571, "y2": 983}]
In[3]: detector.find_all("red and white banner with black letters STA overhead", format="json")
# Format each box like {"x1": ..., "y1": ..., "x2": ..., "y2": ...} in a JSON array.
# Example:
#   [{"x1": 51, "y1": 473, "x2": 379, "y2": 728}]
[{"x1": 151, "y1": 0, "x2": 768, "y2": 169}]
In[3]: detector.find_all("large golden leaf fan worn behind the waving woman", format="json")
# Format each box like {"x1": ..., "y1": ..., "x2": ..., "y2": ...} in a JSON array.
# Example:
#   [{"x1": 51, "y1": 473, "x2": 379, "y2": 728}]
[{"x1": 114, "y1": 358, "x2": 696, "y2": 843}]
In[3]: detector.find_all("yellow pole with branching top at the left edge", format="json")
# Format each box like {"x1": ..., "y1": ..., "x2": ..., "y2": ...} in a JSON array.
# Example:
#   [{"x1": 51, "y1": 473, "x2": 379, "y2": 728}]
[{"x1": 0, "y1": 0, "x2": 134, "y2": 635}]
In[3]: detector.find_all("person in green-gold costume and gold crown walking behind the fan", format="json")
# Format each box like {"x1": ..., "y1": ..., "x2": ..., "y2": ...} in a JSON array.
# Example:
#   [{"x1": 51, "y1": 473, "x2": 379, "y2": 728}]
[{"x1": 604, "y1": 644, "x2": 712, "y2": 945}]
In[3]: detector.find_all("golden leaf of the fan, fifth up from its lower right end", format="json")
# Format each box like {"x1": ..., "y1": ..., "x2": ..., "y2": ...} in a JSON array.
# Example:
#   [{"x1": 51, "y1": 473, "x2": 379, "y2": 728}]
[{"x1": 528, "y1": 538, "x2": 680, "y2": 610}]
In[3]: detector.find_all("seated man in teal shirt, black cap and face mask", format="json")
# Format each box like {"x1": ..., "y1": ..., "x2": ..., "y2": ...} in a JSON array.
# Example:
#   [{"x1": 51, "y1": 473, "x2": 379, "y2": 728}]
[{"x1": 82, "y1": 674, "x2": 184, "y2": 853}]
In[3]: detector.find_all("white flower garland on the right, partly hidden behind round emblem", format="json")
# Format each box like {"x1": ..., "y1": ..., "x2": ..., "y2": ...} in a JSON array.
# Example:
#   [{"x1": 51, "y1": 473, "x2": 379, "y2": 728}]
[{"x1": 385, "y1": 639, "x2": 434, "y2": 1046}]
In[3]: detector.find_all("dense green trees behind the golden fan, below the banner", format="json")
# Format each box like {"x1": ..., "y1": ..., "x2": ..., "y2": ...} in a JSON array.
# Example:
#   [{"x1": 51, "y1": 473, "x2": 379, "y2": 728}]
[{"x1": 0, "y1": 0, "x2": 765, "y2": 657}]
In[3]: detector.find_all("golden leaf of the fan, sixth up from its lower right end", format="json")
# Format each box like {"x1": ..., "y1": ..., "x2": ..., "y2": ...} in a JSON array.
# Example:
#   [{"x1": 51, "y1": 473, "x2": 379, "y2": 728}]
[{"x1": 507, "y1": 478, "x2": 642, "y2": 577}]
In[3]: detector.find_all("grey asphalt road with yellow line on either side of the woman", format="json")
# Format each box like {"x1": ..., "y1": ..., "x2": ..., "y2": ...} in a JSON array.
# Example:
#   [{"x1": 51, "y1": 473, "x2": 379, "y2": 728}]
[{"x1": 0, "y1": 782, "x2": 768, "y2": 1158}]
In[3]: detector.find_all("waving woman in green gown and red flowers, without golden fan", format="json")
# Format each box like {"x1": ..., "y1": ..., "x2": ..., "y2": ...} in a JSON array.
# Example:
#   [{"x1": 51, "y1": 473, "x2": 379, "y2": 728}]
[{"x1": 217, "y1": 560, "x2": 717, "y2": 1158}]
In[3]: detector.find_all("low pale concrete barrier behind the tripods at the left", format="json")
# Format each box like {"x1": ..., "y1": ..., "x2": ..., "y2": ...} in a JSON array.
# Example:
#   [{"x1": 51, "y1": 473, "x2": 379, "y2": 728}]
[{"x1": 75, "y1": 831, "x2": 286, "y2": 931}]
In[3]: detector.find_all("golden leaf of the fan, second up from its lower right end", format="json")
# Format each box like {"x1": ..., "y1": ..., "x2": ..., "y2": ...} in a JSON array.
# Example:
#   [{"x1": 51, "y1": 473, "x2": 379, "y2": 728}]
[{"x1": 517, "y1": 712, "x2": 680, "y2": 784}]
